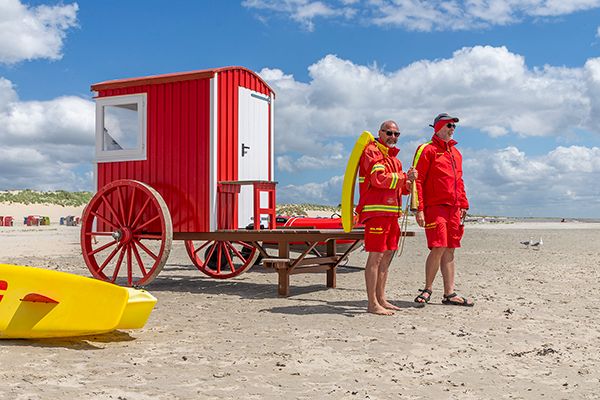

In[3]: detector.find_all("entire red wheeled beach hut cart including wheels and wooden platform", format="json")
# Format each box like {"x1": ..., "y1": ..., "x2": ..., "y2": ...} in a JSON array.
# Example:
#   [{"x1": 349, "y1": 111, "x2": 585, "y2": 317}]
[{"x1": 81, "y1": 67, "x2": 412, "y2": 295}]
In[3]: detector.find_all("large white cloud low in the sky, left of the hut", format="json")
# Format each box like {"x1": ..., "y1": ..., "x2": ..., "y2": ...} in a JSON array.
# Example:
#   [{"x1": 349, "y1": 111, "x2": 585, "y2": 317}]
[{"x1": 0, "y1": 78, "x2": 95, "y2": 190}]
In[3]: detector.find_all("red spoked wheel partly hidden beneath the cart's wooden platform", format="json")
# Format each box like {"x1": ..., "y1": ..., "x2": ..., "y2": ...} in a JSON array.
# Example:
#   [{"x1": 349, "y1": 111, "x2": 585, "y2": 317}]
[{"x1": 185, "y1": 240, "x2": 259, "y2": 279}]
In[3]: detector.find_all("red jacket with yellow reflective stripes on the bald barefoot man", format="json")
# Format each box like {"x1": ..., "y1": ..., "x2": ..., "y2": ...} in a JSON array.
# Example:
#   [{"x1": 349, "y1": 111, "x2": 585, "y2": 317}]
[{"x1": 356, "y1": 140, "x2": 409, "y2": 222}]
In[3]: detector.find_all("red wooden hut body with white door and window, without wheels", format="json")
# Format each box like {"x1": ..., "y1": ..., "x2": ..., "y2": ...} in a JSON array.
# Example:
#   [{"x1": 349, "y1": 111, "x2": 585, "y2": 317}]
[{"x1": 92, "y1": 67, "x2": 275, "y2": 232}]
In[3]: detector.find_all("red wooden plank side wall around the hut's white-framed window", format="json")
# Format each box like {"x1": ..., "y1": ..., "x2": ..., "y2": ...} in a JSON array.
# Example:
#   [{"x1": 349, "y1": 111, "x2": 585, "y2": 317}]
[{"x1": 98, "y1": 79, "x2": 210, "y2": 232}]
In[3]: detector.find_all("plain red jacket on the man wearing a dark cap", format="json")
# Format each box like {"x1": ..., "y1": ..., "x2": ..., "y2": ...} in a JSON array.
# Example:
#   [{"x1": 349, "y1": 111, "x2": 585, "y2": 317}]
[{"x1": 413, "y1": 135, "x2": 469, "y2": 211}]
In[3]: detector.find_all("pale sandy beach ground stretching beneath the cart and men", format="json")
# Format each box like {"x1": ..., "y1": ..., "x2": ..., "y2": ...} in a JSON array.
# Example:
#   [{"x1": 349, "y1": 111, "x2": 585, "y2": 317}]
[{"x1": 0, "y1": 216, "x2": 600, "y2": 400}]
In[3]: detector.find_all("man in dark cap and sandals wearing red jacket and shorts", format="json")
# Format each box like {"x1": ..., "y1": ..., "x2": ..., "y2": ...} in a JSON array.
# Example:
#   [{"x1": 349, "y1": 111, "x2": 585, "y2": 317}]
[{"x1": 413, "y1": 113, "x2": 474, "y2": 307}]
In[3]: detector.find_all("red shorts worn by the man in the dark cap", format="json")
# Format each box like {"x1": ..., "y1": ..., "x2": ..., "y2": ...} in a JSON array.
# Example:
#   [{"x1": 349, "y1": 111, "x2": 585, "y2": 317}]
[{"x1": 424, "y1": 206, "x2": 465, "y2": 249}]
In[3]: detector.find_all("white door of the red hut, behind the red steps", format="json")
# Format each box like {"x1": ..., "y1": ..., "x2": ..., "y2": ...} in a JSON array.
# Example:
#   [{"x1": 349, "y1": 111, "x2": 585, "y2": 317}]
[{"x1": 238, "y1": 87, "x2": 270, "y2": 228}]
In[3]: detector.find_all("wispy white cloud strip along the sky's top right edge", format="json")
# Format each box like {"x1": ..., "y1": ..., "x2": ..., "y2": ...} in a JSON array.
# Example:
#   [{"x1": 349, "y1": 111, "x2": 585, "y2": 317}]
[{"x1": 242, "y1": 0, "x2": 600, "y2": 31}]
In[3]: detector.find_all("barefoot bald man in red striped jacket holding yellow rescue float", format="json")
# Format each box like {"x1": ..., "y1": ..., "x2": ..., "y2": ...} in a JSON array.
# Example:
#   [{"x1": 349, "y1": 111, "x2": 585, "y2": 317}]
[{"x1": 356, "y1": 121, "x2": 417, "y2": 315}]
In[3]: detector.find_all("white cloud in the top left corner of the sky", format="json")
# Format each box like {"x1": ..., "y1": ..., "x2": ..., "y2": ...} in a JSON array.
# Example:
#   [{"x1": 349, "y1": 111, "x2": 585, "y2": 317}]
[{"x1": 0, "y1": 0, "x2": 79, "y2": 64}]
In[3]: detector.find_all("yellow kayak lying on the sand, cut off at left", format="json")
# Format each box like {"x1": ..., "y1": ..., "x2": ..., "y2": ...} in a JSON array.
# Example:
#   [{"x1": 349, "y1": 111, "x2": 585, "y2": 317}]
[{"x1": 0, "y1": 264, "x2": 156, "y2": 339}]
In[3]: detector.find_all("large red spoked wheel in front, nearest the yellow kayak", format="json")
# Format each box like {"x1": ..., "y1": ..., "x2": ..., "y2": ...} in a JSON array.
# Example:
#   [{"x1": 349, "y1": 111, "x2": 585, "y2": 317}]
[{"x1": 81, "y1": 180, "x2": 173, "y2": 286}]
